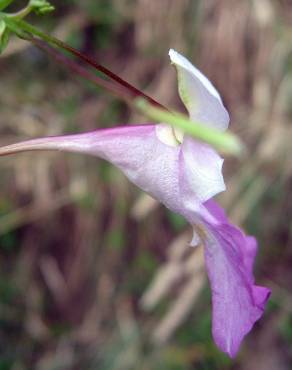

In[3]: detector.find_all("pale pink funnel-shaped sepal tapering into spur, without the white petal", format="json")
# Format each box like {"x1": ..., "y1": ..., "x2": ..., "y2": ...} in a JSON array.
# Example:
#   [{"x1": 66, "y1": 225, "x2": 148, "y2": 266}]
[{"x1": 0, "y1": 125, "x2": 206, "y2": 219}]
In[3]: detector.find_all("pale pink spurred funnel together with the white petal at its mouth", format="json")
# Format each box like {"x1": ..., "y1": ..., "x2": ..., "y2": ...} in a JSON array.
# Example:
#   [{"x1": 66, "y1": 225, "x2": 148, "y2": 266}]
[{"x1": 0, "y1": 125, "x2": 225, "y2": 223}]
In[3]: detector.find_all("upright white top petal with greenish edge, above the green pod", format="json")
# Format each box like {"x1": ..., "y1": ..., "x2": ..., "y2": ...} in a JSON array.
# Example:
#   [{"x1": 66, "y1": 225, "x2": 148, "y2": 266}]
[{"x1": 169, "y1": 49, "x2": 229, "y2": 131}]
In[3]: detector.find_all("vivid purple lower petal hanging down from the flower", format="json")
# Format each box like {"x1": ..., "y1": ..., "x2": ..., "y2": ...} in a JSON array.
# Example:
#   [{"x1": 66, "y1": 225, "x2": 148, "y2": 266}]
[{"x1": 205, "y1": 201, "x2": 270, "y2": 357}]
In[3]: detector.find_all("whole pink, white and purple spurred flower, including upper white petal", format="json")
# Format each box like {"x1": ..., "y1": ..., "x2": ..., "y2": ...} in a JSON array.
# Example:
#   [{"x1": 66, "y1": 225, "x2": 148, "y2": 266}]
[{"x1": 0, "y1": 50, "x2": 270, "y2": 357}]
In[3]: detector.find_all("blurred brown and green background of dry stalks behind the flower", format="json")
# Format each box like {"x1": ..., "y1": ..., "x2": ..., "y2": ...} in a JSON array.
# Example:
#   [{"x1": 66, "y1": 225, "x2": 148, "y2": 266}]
[{"x1": 0, "y1": 0, "x2": 292, "y2": 370}]
